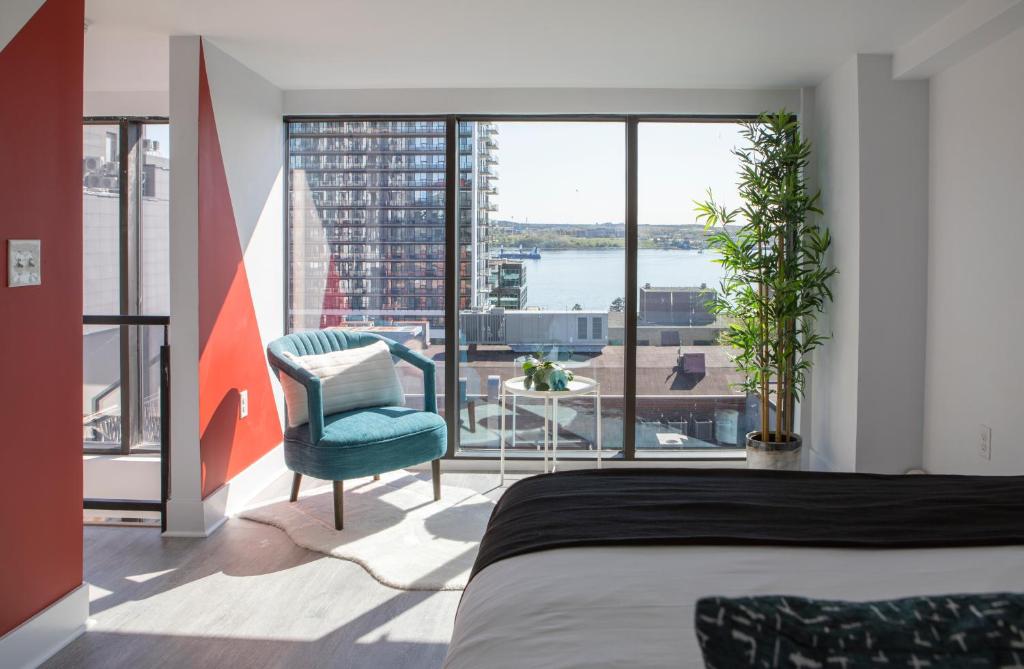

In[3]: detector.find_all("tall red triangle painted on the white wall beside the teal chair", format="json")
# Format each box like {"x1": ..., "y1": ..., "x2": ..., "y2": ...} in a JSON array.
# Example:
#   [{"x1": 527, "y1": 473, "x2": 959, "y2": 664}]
[{"x1": 199, "y1": 44, "x2": 282, "y2": 498}]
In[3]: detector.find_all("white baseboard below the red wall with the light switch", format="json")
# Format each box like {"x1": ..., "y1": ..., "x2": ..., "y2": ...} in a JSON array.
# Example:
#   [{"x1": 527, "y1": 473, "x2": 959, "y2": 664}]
[{"x1": 0, "y1": 583, "x2": 89, "y2": 669}]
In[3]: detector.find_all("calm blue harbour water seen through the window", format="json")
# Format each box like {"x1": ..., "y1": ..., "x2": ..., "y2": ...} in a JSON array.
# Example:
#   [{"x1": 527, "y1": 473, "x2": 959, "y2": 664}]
[{"x1": 523, "y1": 249, "x2": 722, "y2": 310}]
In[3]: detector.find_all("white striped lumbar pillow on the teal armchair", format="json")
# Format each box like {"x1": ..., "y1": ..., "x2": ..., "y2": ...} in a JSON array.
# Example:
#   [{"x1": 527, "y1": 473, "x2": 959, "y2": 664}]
[{"x1": 281, "y1": 341, "x2": 406, "y2": 427}]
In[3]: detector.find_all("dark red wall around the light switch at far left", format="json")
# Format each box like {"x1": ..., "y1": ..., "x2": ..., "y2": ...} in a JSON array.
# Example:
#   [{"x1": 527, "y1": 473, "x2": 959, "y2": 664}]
[{"x1": 0, "y1": 0, "x2": 84, "y2": 634}]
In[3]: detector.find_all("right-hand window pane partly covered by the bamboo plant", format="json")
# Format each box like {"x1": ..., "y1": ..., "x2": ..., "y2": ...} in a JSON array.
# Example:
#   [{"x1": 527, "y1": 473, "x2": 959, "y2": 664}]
[{"x1": 636, "y1": 122, "x2": 745, "y2": 456}]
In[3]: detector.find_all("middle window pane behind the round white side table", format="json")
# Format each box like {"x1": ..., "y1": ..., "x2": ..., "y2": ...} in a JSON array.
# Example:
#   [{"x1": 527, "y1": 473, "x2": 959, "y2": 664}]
[{"x1": 459, "y1": 121, "x2": 626, "y2": 457}]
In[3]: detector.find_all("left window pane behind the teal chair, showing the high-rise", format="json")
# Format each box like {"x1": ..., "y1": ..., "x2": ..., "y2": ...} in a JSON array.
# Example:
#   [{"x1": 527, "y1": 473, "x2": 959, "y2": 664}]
[{"x1": 288, "y1": 120, "x2": 448, "y2": 408}]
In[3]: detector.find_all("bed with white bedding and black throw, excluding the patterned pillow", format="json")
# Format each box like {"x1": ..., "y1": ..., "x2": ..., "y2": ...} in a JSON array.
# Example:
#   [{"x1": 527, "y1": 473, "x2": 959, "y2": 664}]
[{"x1": 444, "y1": 469, "x2": 1024, "y2": 669}]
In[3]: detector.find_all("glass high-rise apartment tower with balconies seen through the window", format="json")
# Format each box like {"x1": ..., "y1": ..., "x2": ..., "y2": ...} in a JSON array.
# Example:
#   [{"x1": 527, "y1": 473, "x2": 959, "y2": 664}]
[{"x1": 288, "y1": 120, "x2": 498, "y2": 330}]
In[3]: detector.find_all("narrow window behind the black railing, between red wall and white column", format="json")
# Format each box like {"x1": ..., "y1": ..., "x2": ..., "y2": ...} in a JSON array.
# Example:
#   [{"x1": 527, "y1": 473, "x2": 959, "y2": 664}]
[{"x1": 82, "y1": 119, "x2": 170, "y2": 453}]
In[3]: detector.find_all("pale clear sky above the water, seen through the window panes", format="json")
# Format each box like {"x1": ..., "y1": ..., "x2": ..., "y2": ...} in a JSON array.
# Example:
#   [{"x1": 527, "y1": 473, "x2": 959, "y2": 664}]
[{"x1": 493, "y1": 121, "x2": 740, "y2": 225}]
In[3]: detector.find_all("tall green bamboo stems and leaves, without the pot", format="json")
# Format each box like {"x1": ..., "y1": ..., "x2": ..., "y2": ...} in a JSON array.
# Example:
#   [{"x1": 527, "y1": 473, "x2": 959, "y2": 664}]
[{"x1": 695, "y1": 110, "x2": 837, "y2": 443}]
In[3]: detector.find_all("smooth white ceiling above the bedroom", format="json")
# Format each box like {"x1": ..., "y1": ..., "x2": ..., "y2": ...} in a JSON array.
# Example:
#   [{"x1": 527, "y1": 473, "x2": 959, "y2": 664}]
[{"x1": 85, "y1": 0, "x2": 964, "y2": 91}]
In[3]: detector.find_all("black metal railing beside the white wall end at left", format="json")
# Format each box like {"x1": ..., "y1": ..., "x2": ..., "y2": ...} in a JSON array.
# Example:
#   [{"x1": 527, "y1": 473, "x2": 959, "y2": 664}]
[{"x1": 82, "y1": 316, "x2": 171, "y2": 532}]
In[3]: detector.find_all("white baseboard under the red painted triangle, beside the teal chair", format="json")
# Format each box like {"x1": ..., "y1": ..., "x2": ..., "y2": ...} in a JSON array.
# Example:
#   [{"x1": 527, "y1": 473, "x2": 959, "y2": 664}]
[{"x1": 164, "y1": 444, "x2": 287, "y2": 537}]
